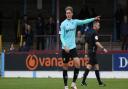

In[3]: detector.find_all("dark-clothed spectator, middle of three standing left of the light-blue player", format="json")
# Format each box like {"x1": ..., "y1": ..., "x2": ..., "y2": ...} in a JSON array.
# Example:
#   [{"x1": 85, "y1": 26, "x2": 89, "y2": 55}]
[{"x1": 36, "y1": 15, "x2": 45, "y2": 50}]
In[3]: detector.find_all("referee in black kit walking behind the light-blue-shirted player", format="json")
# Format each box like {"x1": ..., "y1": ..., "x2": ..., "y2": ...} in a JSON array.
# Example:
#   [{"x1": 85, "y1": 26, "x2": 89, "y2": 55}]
[{"x1": 81, "y1": 21, "x2": 107, "y2": 86}]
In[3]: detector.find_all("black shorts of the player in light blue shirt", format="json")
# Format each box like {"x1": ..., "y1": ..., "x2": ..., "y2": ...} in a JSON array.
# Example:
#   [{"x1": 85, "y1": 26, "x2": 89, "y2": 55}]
[{"x1": 62, "y1": 48, "x2": 78, "y2": 63}]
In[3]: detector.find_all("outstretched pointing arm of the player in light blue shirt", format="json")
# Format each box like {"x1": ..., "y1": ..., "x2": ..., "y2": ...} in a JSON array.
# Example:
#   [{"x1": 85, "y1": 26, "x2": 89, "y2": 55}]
[{"x1": 76, "y1": 16, "x2": 100, "y2": 25}]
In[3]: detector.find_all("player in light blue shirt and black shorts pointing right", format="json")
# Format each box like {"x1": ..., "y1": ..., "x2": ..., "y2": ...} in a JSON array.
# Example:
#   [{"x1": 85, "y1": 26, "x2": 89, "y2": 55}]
[{"x1": 60, "y1": 6, "x2": 100, "y2": 89}]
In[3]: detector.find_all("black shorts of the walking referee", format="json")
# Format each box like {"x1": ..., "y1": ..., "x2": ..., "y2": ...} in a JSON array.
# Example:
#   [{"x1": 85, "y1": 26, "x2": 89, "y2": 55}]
[{"x1": 88, "y1": 52, "x2": 98, "y2": 65}]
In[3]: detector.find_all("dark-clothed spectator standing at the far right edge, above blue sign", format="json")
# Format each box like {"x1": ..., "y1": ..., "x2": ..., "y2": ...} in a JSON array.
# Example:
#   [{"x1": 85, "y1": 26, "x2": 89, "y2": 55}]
[{"x1": 121, "y1": 15, "x2": 128, "y2": 50}]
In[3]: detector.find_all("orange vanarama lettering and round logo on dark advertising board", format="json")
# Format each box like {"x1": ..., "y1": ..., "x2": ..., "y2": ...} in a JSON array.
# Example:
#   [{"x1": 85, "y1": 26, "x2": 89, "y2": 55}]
[{"x1": 26, "y1": 55, "x2": 88, "y2": 70}]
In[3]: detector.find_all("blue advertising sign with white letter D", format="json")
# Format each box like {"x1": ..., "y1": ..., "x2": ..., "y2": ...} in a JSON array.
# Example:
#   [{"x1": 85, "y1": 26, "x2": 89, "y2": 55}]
[{"x1": 112, "y1": 53, "x2": 128, "y2": 71}]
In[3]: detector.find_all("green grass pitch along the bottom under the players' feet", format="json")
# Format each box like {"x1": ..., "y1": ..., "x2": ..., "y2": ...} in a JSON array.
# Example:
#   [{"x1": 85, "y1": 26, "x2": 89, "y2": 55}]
[{"x1": 0, "y1": 78, "x2": 128, "y2": 89}]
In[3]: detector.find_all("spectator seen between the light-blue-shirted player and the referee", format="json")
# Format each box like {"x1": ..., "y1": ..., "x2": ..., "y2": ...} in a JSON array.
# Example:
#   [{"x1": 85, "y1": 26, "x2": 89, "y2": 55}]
[{"x1": 76, "y1": 31, "x2": 84, "y2": 50}]
